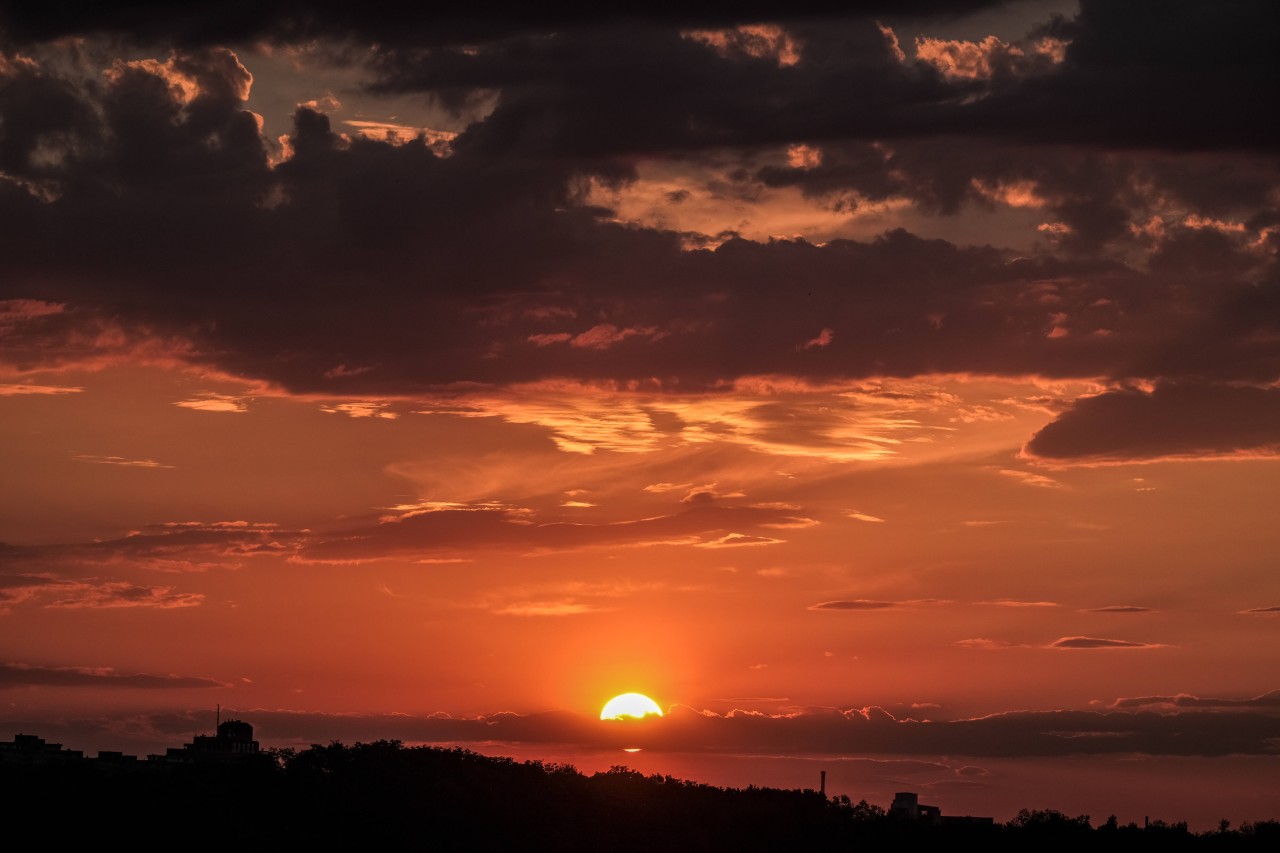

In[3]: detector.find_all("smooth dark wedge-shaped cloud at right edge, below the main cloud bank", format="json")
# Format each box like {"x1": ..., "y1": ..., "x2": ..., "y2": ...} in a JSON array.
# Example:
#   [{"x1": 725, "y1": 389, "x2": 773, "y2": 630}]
[{"x1": 1027, "y1": 383, "x2": 1280, "y2": 461}]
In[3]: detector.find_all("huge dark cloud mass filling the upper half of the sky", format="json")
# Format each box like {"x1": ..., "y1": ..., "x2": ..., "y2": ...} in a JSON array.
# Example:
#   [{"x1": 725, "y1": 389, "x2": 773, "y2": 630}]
[{"x1": 0, "y1": 1, "x2": 1280, "y2": 460}]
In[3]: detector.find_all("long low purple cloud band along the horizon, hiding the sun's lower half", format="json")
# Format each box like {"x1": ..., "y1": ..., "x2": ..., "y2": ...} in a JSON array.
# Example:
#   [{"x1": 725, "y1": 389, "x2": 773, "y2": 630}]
[{"x1": 10, "y1": 706, "x2": 1280, "y2": 758}]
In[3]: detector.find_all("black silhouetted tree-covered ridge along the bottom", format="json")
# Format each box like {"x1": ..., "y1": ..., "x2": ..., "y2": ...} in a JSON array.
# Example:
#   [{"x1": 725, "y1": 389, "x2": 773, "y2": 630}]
[{"x1": 0, "y1": 740, "x2": 1280, "y2": 853}]
